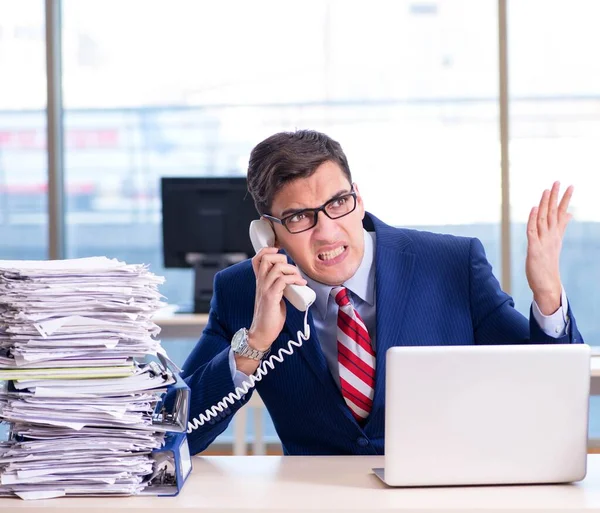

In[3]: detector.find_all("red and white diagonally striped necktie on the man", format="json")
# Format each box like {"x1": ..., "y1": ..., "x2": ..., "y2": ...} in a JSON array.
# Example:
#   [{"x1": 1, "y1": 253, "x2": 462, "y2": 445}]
[{"x1": 331, "y1": 287, "x2": 375, "y2": 422}]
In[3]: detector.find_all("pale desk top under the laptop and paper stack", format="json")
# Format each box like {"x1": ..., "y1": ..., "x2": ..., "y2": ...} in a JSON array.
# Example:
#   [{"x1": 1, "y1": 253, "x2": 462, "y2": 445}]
[{"x1": 0, "y1": 455, "x2": 600, "y2": 513}]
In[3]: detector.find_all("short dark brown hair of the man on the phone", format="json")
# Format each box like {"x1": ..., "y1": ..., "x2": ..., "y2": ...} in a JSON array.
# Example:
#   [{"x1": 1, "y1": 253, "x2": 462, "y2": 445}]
[{"x1": 248, "y1": 130, "x2": 352, "y2": 214}]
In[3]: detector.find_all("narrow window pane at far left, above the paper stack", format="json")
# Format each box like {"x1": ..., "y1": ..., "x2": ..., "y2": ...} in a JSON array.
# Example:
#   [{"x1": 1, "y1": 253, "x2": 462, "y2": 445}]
[{"x1": 0, "y1": 0, "x2": 48, "y2": 259}]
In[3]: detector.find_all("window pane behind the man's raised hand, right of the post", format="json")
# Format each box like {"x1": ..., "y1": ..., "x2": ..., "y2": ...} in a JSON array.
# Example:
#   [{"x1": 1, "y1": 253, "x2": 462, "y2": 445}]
[{"x1": 508, "y1": 0, "x2": 600, "y2": 438}]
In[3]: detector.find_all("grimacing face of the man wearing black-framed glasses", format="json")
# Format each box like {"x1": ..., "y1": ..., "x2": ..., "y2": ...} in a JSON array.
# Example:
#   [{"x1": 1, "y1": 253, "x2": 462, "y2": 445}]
[{"x1": 271, "y1": 161, "x2": 365, "y2": 285}]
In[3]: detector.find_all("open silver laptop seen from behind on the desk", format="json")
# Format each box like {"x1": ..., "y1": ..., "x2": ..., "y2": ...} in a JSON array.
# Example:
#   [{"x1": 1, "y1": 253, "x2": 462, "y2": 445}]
[{"x1": 373, "y1": 344, "x2": 591, "y2": 486}]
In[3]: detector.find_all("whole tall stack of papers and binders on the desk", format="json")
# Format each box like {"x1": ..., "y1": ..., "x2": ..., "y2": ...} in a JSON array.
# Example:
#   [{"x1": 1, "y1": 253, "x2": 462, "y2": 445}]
[{"x1": 0, "y1": 257, "x2": 191, "y2": 499}]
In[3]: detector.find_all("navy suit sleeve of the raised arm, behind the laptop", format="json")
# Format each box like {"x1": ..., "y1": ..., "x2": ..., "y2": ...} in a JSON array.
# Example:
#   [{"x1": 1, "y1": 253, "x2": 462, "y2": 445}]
[{"x1": 469, "y1": 239, "x2": 583, "y2": 344}]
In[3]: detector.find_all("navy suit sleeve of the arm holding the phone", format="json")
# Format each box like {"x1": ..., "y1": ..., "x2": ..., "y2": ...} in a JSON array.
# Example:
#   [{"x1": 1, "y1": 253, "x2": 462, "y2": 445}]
[{"x1": 181, "y1": 274, "x2": 253, "y2": 454}]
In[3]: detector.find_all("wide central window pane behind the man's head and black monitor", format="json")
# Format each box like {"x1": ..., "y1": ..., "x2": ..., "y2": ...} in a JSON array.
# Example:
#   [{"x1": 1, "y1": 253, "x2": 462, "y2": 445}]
[{"x1": 63, "y1": 0, "x2": 500, "y2": 306}]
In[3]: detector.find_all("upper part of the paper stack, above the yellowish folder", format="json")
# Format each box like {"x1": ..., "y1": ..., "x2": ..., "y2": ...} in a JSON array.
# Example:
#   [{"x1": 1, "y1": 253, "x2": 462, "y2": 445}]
[{"x1": 0, "y1": 257, "x2": 165, "y2": 368}]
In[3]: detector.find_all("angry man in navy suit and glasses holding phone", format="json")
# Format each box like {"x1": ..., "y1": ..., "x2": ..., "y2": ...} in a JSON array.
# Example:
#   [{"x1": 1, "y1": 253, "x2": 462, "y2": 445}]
[{"x1": 183, "y1": 131, "x2": 582, "y2": 455}]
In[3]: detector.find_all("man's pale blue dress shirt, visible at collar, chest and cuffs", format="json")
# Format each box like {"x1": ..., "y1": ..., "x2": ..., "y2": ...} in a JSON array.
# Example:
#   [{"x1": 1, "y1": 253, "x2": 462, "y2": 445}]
[{"x1": 229, "y1": 230, "x2": 568, "y2": 387}]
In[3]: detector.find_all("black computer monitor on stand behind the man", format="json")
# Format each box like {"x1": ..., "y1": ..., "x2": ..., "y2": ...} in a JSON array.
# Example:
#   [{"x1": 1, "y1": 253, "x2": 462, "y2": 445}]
[{"x1": 161, "y1": 176, "x2": 259, "y2": 313}]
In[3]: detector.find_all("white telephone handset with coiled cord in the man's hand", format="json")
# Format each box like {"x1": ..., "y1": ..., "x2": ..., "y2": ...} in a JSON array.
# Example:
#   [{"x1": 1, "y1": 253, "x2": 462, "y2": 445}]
[{"x1": 187, "y1": 219, "x2": 316, "y2": 433}]
